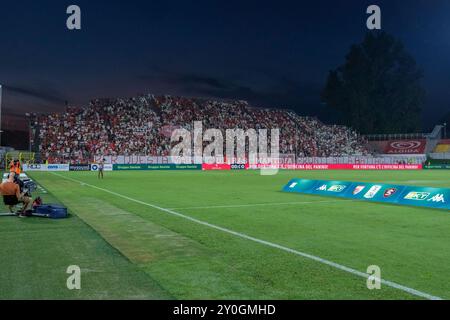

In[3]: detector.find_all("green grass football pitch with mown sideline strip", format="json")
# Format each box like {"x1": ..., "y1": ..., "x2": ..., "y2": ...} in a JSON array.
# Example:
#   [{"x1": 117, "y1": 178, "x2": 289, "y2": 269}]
[{"x1": 0, "y1": 170, "x2": 450, "y2": 299}]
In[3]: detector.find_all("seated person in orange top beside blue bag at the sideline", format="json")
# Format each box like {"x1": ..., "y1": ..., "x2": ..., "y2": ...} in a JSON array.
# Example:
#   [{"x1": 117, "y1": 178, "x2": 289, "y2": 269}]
[{"x1": 0, "y1": 172, "x2": 33, "y2": 218}]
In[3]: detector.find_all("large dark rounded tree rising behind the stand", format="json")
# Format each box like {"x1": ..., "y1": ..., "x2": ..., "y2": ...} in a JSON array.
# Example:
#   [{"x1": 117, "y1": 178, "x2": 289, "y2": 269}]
[{"x1": 322, "y1": 32, "x2": 425, "y2": 133}]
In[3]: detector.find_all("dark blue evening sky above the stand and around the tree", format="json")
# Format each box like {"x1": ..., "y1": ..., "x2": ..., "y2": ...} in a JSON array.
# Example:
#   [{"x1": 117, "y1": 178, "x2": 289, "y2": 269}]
[{"x1": 0, "y1": 0, "x2": 450, "y2": 129}]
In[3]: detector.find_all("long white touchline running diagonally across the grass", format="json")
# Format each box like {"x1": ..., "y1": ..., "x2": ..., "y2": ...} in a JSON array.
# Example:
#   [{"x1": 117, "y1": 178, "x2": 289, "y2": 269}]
[{"x1": 51, "y1": 172, "x2": 442, "y2": 300}]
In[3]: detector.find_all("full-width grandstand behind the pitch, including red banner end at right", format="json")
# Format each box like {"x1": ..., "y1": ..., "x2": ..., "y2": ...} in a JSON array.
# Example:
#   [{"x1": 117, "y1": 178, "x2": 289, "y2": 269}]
[{"x1": 26, "y1": 90, "x2": 450, "y2": 164}]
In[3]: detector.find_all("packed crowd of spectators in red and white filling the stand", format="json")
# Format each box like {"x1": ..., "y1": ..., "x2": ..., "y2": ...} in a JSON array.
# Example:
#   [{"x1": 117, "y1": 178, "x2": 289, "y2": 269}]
[{"x1": 33, "y1": 95, "x2": 368, "y2": 162}]
